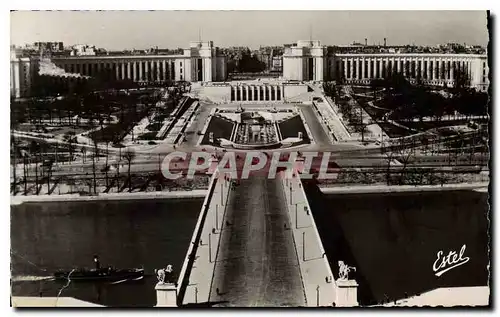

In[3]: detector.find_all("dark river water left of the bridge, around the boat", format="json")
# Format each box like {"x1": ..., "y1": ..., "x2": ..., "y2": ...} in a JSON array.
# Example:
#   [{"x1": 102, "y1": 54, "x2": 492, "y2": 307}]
[{"x1": 11, "y1": 199, "x2": 203, "y2": 307}]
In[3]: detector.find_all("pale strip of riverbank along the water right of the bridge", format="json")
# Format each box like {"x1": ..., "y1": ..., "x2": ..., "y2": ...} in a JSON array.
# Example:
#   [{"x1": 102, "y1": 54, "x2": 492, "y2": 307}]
[{"x1": 319, "y1": 182, "x2": 489, "y2": 194}]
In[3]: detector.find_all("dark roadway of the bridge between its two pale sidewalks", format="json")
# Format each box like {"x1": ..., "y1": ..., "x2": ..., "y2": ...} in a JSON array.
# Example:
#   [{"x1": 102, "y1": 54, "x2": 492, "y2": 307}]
[{"x1": 210, "y1": 177, "x2": 305, "y2": 307}]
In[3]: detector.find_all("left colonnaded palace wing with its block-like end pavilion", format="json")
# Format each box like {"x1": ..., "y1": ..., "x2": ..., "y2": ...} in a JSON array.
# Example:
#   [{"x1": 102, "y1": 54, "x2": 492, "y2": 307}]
[{"x1": 10, "y1": 41, "x2": 227, "y2": 98}]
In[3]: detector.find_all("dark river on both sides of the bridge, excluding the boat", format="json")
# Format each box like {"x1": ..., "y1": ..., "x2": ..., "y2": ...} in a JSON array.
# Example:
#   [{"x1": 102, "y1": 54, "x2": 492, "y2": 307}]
[{"x1": 11, "y1": 189, "x2": 489, "y2": 307}]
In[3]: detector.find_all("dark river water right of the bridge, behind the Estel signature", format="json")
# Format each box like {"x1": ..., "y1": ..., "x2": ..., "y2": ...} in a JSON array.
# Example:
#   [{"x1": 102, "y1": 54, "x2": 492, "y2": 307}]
[{"x1": 313, "y1": 190, "x2": 489, "y2": 305}]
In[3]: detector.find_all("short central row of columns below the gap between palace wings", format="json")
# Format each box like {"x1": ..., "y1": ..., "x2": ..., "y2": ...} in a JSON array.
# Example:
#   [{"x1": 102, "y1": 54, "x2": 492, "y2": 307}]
[{"x1": 231, "y1": 85, "x2": 284, "y2": 101}]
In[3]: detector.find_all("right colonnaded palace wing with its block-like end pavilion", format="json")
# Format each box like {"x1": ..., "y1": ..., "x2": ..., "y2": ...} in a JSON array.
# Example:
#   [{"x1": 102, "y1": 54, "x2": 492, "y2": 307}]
[{"x1": 283, "y1": 41, "x2": 489, "y2": 91}]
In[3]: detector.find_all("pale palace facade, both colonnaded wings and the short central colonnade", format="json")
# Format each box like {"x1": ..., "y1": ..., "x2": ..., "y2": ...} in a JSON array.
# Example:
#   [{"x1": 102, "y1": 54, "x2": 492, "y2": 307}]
[{"x1": 10, "y1": 41, "x2": 489, "y2": 101}]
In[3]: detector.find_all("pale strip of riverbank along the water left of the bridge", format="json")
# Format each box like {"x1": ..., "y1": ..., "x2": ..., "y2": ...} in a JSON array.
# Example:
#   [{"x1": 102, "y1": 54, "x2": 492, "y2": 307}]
[{"x1": 10, "y1": 189, "x2": 207, "y2": 205}]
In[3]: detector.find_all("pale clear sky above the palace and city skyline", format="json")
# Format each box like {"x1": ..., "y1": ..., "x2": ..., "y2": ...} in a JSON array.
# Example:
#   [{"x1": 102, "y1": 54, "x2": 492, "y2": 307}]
[{"x1": 10, "y1": 11, "x2": 488, "y2": 50}]
